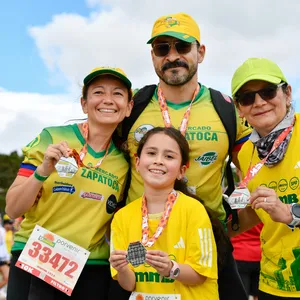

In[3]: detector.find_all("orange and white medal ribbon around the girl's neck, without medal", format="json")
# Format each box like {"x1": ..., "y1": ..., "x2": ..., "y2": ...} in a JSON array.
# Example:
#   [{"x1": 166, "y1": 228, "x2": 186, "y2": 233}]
[{"x1": 142, "y1": 190, "x2": 178, "y2": 247}]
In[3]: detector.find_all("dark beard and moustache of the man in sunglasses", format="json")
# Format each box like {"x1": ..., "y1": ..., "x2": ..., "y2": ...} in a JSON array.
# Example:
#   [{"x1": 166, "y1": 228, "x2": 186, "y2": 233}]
[{"x1": 155, "y1": 60, "x2": 198, "y2": 86}]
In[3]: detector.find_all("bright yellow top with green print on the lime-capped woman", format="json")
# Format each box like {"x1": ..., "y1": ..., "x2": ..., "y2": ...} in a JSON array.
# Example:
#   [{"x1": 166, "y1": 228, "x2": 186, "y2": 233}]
[{"x1": 238, "y1": 114, "x2": 300, "y2": 298}]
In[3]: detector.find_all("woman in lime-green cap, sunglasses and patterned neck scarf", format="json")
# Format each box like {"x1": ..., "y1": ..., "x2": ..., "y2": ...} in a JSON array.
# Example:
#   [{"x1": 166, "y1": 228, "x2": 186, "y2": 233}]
[{"x1": 228, "y1": 58, "x2": 300, "y2": 300}]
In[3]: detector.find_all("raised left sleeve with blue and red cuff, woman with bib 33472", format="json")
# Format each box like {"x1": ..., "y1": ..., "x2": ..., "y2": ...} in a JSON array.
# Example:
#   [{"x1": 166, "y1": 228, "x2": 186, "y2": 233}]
[{"x1": 18, "y1": 129, "x2": 53, "y2": 177}]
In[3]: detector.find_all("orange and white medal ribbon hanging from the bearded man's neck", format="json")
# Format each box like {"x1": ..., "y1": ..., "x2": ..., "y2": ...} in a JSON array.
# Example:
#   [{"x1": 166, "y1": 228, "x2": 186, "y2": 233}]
[{"x1": 157, "y1": 83, "x2": 200, "y2": 136}]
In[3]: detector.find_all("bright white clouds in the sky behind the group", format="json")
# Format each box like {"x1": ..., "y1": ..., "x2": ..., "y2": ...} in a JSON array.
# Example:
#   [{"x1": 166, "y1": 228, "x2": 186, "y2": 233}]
[{"x1": 0, "y1": 0, "x2": 300, "y2": 151}]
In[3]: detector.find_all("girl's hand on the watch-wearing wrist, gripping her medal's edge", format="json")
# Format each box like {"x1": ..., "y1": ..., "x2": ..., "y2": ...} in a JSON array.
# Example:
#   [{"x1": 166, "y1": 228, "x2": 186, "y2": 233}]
[{"x1": 146, "y1": 250, "x2": 173, "y2": 277}]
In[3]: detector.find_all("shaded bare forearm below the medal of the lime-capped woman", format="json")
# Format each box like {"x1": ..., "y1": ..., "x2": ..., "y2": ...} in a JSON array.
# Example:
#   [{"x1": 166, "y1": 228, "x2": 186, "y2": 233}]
[{"x1": 226, "y1": 206, "x2": 261, "y2": 237}]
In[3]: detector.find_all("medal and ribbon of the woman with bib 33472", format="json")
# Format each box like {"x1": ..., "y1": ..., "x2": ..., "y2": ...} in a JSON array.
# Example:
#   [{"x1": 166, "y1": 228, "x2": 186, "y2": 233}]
[{"x1": 55, "y1": 122, "x2": 111, "y2": 178}]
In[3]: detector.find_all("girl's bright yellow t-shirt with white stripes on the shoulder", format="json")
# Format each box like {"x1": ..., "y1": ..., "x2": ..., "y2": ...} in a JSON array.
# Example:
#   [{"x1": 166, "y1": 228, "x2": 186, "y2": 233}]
[{"x1": 111, "y1": 193, "x2": 219, "y2": 300}]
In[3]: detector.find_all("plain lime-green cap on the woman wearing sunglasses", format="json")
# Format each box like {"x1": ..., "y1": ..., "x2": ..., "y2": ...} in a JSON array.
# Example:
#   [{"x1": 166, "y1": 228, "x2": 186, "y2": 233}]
[{"x1": 231, "y1": 58, "x2": 287, "y2": 97}]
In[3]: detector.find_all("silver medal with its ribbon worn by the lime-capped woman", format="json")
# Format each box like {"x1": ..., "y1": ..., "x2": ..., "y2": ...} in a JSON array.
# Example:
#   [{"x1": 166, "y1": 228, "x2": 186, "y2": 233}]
[{"x1": 225, "y1": 118, "x2": 295, "y2": 209}]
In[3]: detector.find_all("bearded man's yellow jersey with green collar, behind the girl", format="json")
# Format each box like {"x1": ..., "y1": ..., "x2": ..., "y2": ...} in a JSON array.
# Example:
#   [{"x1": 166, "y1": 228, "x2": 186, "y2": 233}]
[{"x1": 128, "y1": 85, "x2": 251, "y2": 218}]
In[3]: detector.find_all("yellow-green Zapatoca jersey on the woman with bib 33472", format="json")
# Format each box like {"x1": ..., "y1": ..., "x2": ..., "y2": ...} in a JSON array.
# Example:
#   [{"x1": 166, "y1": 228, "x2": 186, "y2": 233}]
[{"x1": 15, "y1": 124, "x2": 128, "y2": 259}]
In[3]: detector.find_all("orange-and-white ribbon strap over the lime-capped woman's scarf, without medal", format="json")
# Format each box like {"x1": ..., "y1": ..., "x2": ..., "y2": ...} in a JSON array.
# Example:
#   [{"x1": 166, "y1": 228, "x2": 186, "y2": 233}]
[{"x1": 239, "y1": 118, "x2": 295, "y2": 188}]
